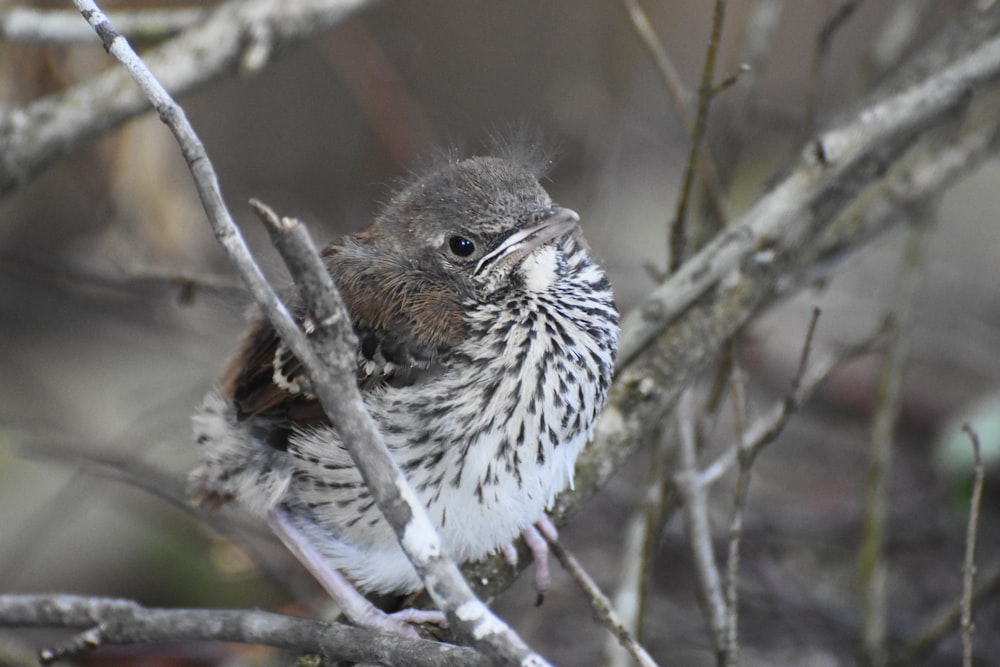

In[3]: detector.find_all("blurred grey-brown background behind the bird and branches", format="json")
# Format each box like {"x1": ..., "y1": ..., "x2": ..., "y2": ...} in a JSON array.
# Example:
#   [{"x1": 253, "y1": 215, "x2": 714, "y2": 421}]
[{"x1": 0, "y1": 0, "x2": 1000, "y2": 666}]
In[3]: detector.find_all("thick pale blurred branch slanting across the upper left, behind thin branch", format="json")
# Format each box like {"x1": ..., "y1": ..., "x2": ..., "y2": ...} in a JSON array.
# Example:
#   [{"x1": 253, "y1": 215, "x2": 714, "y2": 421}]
[{"x1": 0, "y1": 0, "x2": 373, "y2": 198}]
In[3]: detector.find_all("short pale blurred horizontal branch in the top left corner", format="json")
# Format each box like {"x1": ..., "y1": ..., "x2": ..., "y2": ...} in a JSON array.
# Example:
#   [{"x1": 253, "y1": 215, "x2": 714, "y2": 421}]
[{"x1": 0, "y1": 7, "x2": 208, "y2": 45}]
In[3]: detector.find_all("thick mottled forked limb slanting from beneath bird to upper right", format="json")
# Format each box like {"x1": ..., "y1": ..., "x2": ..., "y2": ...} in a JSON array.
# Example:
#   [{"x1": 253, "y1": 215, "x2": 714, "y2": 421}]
[{"x1": 463, "y1": 6, "x2": 1000, "y2": 597}]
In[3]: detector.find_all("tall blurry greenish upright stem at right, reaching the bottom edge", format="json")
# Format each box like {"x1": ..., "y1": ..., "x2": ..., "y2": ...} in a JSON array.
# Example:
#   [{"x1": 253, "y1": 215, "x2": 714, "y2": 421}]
[{"x1": 858, "y1": 224, "x2": 925, "y2": 665}]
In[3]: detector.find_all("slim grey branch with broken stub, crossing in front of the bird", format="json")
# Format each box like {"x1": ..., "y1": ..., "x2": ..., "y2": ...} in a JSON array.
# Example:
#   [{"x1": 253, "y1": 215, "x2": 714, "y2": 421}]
[{"x1": 74, "y1": 0, "x2": 545, "y2": 665}]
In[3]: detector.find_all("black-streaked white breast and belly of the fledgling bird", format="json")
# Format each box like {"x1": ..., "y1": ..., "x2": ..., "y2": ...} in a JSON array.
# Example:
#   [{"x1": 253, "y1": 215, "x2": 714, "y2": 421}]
[{"x1": 289, "y1": 239, "x2": 618, "y2": 558}]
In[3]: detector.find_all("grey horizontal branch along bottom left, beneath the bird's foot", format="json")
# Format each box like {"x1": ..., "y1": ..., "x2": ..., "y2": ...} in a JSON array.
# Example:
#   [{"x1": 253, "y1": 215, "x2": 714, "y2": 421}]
[{"x1": 0, "y1": 595, "x2": 493, "y2": 667}]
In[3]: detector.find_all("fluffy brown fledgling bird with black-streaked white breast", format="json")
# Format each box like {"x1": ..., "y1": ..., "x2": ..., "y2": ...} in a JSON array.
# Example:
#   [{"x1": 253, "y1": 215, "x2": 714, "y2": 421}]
[{"x1": 189, "y1": 153, "x2": 618, "y2": 633}]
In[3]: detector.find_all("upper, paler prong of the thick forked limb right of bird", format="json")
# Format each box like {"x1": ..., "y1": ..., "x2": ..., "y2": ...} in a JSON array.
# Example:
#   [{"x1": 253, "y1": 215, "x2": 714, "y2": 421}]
[{"x1": 618, "y1": 6, "x2": 1000, "y2": 368}]
